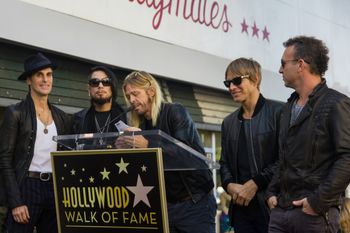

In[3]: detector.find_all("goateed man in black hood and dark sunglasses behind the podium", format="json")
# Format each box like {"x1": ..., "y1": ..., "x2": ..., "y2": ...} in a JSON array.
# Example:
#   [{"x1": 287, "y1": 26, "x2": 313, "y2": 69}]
[{"x1": 74, "y1": 66, "x2": 126, "y2": 137}]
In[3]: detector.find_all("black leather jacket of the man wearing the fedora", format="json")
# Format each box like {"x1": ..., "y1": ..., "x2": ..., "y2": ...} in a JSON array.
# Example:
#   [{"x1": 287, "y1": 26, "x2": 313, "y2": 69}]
[{"x1": 0, "y1": 94, "x2": 71, "y2": 209}]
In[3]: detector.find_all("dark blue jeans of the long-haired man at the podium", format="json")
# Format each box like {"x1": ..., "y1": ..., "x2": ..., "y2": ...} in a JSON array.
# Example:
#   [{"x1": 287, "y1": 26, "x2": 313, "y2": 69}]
[{"x1": 168, "y1": 192, "x2": 216, "y2": 233}]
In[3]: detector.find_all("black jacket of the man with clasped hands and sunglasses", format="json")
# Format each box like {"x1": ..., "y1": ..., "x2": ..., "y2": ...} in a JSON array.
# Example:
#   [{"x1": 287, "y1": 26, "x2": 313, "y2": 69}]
[{"x1": 220, "y1": 95, "x2": 283, "y2": 200}]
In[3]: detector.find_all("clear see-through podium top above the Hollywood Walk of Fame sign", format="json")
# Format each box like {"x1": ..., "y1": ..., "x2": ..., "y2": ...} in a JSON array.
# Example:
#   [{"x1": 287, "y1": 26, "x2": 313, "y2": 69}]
[{"x1": 53, "y1": 130, "x2": 219, "y2": 171}]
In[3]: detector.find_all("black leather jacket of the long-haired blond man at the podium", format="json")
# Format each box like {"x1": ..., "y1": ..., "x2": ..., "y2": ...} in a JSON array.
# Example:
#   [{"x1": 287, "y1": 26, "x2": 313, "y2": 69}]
[{"x1": 141, "y1": 103, "x2": 214, "y2": 203}]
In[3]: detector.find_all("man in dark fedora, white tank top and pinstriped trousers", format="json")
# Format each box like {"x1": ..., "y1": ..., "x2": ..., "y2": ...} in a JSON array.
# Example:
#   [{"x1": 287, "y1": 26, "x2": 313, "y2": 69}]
[{"x1": 0, "y1": 53, "x2": 71, "y2": 233}]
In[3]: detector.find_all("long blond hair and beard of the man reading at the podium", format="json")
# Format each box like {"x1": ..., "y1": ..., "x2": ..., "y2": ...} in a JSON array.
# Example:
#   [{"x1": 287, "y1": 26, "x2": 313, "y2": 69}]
[{"x1": 123, "y1": 71, "x2": 163, "y2": 127}]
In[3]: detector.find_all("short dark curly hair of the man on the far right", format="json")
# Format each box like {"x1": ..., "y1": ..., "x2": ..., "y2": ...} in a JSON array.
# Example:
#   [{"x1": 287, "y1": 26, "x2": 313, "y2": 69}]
[{"x1": 283, "y1": 36, "x2": 329, "y2": 77}]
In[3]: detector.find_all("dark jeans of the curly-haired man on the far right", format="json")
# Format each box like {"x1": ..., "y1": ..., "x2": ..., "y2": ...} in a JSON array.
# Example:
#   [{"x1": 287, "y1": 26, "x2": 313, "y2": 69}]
[{"x1": 269, "y1": 207, "x2": 339, "y2": 233}]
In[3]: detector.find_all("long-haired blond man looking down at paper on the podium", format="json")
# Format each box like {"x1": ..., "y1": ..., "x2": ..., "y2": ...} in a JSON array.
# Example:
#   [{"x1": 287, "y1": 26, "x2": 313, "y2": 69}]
[{"x1": 117, "y1": 71, "x2": 216, "y2": 233}]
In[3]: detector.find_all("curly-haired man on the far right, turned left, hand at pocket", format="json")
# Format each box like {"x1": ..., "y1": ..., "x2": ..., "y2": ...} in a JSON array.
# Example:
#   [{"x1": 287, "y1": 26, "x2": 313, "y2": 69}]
[{"x1": 268, "y1": 36, "x2": 350, "y2": 233}]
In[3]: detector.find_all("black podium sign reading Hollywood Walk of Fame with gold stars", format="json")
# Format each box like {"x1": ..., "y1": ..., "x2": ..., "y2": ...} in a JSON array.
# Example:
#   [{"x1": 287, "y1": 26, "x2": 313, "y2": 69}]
[{"x1": 52, "y1": 148, "x2": 169, "y2": 233}]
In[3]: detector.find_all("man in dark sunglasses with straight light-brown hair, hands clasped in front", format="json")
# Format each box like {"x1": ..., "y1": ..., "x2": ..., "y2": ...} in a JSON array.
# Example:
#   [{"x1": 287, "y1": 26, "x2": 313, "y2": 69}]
[{"x1": 220, "y1": 58, "x2": 283, "y2": 233}]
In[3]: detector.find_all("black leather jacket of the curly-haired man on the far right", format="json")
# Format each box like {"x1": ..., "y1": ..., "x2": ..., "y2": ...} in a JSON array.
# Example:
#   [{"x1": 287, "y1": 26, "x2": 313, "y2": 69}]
[{"x1": 269, "y1": 80, "x2": 350, "y2": 214}]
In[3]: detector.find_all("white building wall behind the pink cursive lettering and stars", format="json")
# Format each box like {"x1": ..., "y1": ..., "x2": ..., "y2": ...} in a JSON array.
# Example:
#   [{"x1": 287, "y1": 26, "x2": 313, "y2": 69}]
[{"x1": 0, "y1": 0, "x2": 350, "y2": 100}]
